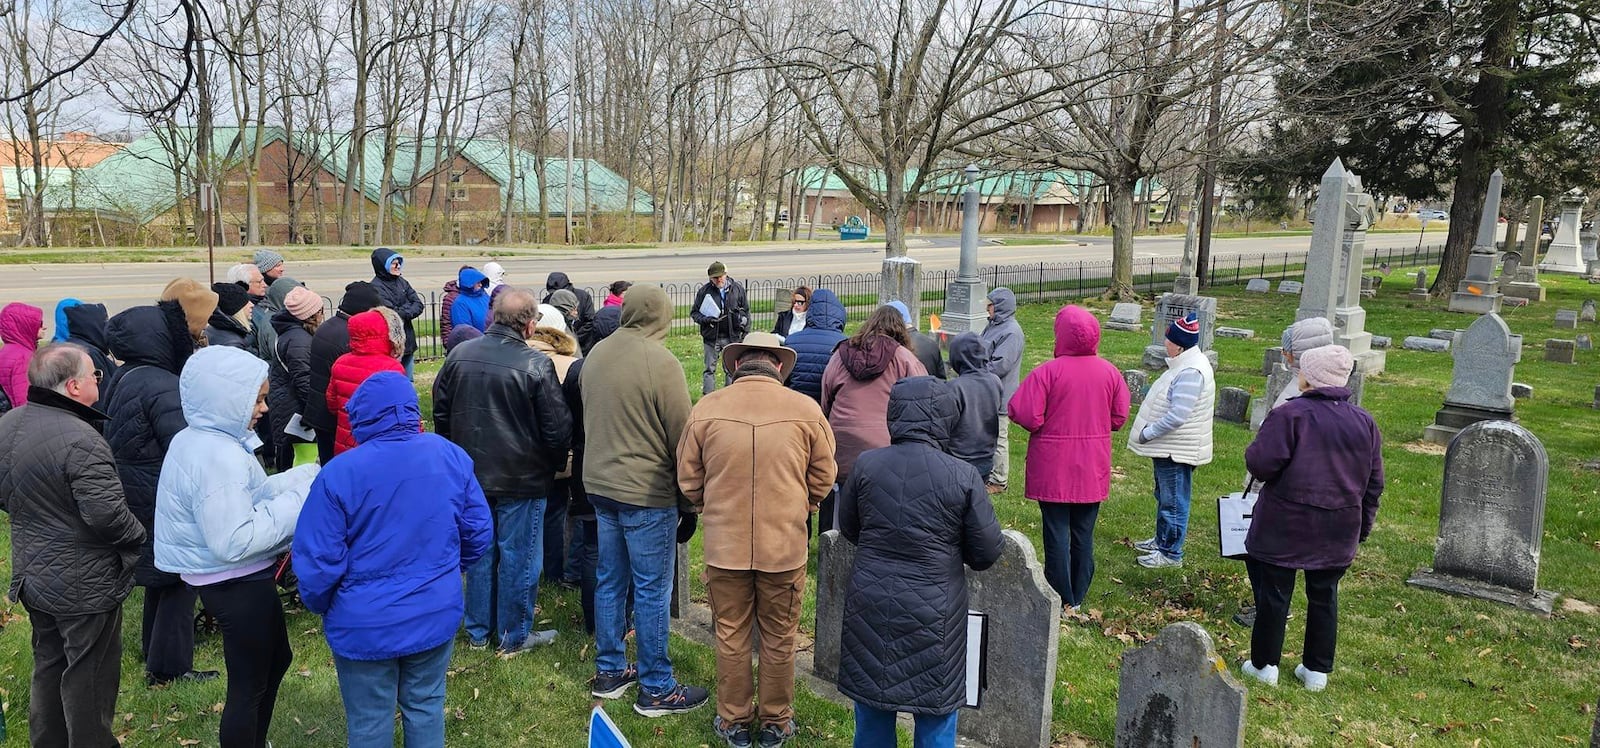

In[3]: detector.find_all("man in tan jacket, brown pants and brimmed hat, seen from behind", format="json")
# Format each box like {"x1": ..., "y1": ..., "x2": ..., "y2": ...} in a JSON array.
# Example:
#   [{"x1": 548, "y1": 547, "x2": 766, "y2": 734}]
[{"x1": 678, "y1": 332, "x2": 837, "y2": 748}]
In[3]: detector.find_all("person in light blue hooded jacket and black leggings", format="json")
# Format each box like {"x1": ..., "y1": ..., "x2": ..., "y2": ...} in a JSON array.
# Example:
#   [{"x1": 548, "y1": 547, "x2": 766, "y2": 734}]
[{"x1": 155, "y1": 347, "x2": 317, "y2": 748}]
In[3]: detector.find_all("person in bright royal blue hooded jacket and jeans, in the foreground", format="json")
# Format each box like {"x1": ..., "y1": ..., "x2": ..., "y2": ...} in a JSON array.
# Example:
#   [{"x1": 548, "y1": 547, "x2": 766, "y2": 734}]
[{"x1": 291, "y1": 374, "x2": 494, "y2": 748}]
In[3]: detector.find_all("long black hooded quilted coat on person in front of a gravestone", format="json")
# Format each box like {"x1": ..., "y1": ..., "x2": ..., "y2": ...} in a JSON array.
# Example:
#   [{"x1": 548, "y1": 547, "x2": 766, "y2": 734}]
[{"x1": 838, "y1": 377, "x2": 1000, "y2": 714}]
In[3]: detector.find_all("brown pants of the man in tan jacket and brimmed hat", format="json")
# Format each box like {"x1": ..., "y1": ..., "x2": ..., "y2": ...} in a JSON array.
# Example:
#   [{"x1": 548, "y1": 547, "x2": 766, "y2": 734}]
[{"x1": 706, "y1": 566, "x2": 805, "y2": 727}]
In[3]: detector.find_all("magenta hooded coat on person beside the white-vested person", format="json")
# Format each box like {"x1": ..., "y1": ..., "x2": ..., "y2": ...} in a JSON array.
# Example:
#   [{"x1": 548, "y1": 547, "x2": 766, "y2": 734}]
[{"x1": 1008, "y1": 305, "x2": 1128, "y2": 503}]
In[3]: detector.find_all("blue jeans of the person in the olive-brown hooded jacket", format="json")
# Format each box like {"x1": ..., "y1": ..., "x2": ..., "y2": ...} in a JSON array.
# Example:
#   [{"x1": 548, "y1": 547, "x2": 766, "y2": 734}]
[{"x1": 595, "y1": 497, "x2": 678, "y2": 695}]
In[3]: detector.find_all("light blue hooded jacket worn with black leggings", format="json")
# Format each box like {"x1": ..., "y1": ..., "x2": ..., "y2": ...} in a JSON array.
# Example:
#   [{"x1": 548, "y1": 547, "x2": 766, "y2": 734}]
[{"x1": 155, "y1": 347, "x2": 317, "y2": 587}]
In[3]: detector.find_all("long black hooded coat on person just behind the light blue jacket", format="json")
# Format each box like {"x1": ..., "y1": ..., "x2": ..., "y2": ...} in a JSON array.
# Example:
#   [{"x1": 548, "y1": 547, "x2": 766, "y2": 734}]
[{"x1": 101, "y1": 300, "x2": 194, "y2": 587}]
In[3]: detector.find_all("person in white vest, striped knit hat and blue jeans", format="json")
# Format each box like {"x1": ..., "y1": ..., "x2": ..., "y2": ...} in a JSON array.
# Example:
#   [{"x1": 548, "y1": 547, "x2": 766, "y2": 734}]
[{"x1": 1128, "y1": 313, "x2": 1216, "y2": 569}]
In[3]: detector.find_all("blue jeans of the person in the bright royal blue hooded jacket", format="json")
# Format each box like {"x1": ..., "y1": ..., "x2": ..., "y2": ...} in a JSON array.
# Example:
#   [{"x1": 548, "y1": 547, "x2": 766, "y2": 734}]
[{"x1": 333, "y1": 641, "x2": 454, "y2": 748}]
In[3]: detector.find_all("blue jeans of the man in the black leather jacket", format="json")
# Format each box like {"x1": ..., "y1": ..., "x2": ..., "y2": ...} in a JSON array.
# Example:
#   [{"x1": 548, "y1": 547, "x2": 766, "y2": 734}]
[{"x1": 466, "y1": 499, "x2": 544, "y2": 651}]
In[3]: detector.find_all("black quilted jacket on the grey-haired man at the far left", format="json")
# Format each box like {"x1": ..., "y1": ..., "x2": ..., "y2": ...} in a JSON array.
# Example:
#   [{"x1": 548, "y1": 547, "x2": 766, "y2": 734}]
[{"x1": 0, "y1": 387, "x2": 144, "y2": 615}]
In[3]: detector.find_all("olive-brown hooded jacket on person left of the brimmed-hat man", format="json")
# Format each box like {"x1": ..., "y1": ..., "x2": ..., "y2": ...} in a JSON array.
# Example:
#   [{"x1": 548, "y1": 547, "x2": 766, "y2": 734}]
[{"x1": 581, "y1": 286, "x2": 690, "y2": 510}]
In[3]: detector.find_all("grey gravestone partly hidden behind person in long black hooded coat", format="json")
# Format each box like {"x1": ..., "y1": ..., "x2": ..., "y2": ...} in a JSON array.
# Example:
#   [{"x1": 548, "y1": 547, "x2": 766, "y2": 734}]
[{"x1": 813, "y1": 531, "x2": 1061, "y2": 748}]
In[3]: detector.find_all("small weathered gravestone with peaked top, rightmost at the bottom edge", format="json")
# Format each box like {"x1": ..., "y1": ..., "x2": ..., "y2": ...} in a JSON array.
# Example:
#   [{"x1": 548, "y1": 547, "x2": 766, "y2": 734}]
[{"x1": 1117, "y1": 622, "x2": 1248, "y2": 748}]
